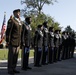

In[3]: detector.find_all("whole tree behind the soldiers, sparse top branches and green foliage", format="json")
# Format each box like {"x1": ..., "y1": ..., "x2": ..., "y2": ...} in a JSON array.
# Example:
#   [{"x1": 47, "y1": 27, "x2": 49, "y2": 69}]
[{"x1": 21, "y1": 0, "x2": 59, "y2": 36}]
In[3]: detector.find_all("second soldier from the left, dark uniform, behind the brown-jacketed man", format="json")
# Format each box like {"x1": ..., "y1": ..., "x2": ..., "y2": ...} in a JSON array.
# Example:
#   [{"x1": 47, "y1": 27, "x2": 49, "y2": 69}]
[{"x1": 21, "y1": 17, "x2": 32, "y2": 70}]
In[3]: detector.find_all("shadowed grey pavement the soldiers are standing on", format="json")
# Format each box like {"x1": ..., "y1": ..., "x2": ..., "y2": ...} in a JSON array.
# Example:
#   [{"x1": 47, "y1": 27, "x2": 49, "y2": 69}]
[{"x1": 0, "y1": 54, "x2": 76, "y2": 75}]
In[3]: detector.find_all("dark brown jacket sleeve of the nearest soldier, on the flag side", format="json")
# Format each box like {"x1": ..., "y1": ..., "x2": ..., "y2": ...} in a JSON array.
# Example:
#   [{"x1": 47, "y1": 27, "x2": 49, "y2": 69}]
[{"x1": 6, "y1": 20, "x2": 13, "y2": 42}]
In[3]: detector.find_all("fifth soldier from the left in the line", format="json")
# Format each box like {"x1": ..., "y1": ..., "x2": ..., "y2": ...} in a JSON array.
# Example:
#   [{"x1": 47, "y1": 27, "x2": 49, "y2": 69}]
[{"x1": 48, "y1": 27, "x2": 54, "y2": 63}]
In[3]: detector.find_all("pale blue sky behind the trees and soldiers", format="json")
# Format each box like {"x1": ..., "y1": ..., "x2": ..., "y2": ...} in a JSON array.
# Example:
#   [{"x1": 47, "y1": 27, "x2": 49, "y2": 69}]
[{"x1": 0, "y1": 0, "x2": 76, "y2": 31}]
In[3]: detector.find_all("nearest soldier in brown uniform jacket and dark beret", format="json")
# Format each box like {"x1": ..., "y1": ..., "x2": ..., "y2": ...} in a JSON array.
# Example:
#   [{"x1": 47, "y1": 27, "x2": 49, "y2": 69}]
[{"x1": 6, "y1": 9, "x2": 22, "y2": 75}]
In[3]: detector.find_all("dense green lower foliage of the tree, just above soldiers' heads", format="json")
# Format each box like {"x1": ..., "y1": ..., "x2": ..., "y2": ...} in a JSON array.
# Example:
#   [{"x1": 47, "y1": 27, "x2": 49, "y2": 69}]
[{"x1": 31, "y1": 14, "x2": 61, "y2": 36}]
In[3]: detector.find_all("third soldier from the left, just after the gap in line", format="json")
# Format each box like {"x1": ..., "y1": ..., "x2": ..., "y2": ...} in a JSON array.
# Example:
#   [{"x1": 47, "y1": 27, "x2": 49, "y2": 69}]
[{"x1": 34, "y1": 25, "x2": 43, "y2": 67}]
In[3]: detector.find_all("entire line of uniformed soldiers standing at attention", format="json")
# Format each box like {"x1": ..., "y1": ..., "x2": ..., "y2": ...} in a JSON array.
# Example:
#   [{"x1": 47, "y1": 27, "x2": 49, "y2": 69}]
[{"x1": 6, "y1": 9, "x2": 75, "y2": 75}]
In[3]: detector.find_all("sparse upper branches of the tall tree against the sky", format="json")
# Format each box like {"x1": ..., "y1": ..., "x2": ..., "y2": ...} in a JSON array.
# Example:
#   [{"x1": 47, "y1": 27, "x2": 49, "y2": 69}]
[{"x1": 21, "y1": 0, "x2": 57, "y2": 16}]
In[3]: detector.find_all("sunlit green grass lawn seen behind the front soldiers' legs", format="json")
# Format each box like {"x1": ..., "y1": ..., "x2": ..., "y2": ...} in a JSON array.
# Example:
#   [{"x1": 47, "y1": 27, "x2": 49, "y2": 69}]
[{"x1": 0, "y1": 49, "x2": 34, "y2": 60}]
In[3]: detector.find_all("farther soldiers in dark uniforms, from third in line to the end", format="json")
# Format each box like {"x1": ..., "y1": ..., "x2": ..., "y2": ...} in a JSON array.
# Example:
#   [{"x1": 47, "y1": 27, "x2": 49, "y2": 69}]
[{"x1": 34, "y1": 22, "x2": 75, "y2": 66}]
